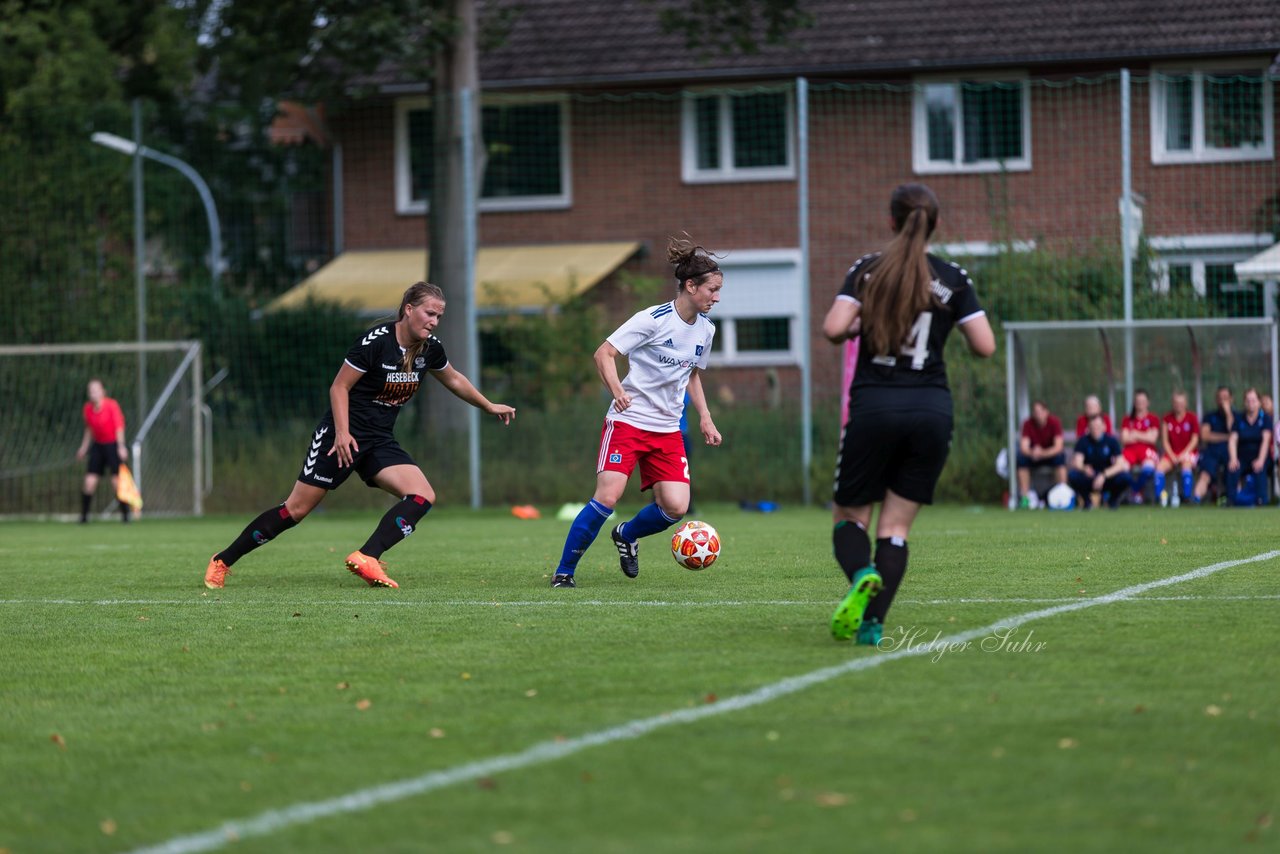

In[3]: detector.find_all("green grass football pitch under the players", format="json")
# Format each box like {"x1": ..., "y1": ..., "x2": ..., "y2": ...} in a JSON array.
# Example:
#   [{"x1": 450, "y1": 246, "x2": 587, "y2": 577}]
[{"x1": 0, "y1": 506, "x2": 1280, "y2": 854}]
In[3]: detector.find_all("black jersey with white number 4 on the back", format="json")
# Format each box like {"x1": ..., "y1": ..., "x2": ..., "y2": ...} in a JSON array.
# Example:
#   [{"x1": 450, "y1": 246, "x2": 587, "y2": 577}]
[{"x1": 837, "y1": 252, "x2": 984, "y2": 389}]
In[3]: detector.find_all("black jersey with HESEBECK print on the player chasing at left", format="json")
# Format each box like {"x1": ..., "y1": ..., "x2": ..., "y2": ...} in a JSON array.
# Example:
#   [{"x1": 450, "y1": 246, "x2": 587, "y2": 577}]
[{"x1": 326, "y1": 323, "x2": 449, "y2": 435}]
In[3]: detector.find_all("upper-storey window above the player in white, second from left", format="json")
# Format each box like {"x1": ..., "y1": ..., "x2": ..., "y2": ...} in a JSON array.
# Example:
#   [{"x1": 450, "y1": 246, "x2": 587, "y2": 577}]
[{"x1": 681, "y1": 91, "x2": 795, "y2": 183}]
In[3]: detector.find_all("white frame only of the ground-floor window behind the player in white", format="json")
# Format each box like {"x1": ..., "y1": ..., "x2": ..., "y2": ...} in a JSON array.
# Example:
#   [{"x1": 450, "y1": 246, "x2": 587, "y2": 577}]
[{"x1": 709, "y1": 248, "x2": 808, "y2": 367}]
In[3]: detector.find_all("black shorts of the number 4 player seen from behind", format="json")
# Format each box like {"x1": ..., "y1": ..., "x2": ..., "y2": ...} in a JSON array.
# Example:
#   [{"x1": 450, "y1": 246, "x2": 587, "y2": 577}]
[{"x1": 835, "y1": 388, "x2": 952, "y2": 507}]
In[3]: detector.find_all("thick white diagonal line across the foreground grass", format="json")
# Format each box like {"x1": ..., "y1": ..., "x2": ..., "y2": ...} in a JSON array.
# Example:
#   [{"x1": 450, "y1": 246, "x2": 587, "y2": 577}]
[{"x1": 122, "y1": 551, "x2": 1280, "y2": 854}]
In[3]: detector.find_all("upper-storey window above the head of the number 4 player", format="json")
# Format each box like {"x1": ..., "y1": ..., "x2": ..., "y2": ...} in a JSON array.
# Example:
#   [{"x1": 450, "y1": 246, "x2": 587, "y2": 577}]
[{"x1": 913, "y1": 79, "x2": 1032, "y2": 173}]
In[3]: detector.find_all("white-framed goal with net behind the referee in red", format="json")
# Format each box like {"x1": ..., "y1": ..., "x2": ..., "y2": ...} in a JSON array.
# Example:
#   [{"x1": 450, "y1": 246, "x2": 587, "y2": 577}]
[{"x1": 0, "y1": 341, "x2": 207, "y2": 520}]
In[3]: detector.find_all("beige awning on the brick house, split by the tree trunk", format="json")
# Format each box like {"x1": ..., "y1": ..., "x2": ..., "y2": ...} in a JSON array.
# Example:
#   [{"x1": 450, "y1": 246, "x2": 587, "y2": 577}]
[{"x1": 266, "y1": 241, "x2": 640, "y2": 314}]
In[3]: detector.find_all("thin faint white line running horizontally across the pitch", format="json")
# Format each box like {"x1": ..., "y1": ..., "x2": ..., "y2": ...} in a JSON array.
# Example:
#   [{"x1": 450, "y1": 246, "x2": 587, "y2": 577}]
[{"x1": 0, "y1": 593, "x2": 1280, "y2": 608}]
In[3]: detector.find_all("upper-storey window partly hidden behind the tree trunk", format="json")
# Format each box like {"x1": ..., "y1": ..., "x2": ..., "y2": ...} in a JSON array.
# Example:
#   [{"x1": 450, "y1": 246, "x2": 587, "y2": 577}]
[{"x1": 396, "y1": 99, "x2": 571, "y2": 214}]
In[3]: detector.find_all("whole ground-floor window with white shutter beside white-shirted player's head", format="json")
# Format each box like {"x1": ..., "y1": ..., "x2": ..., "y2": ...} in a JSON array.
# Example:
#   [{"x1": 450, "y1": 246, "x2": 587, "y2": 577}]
[{"x1": 710, "y1": 250, "x2": 804, "y2": 366}]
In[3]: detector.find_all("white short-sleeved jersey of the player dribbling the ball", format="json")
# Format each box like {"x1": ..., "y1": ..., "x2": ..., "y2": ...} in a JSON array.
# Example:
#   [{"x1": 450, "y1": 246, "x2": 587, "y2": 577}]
[{"x1": 604, "y1": 300, "x2": 716, "y2": 433}]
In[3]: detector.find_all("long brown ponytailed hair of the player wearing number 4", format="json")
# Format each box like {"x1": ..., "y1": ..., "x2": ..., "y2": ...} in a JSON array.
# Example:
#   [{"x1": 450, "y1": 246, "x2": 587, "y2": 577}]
[{"x1": 861, "y1": 184, "x2": 938, "y2": 356}]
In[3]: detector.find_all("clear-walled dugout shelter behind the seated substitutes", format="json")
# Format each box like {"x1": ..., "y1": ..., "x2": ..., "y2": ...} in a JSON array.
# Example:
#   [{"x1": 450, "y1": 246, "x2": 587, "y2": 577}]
[{"x1": 1005, "y1": 318, "x2": 1280, "y2": 495}]
